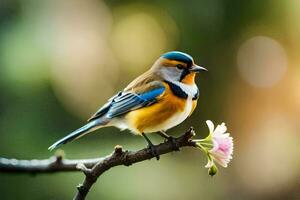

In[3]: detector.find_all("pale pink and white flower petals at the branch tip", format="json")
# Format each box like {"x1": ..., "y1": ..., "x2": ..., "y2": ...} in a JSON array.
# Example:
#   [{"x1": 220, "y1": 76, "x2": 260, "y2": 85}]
[{"x1": 205, "y1": 120, "x2": 233, "y2": 168}]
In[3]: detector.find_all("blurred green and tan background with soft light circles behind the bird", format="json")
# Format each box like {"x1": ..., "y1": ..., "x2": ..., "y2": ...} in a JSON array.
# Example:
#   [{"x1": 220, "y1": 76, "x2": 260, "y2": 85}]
[{"x1": 0, "y1": 0, "x2": 300, "y2": 200}]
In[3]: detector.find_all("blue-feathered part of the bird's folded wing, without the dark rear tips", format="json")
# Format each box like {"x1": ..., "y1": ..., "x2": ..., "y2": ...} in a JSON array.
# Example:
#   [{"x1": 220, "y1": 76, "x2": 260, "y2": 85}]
[{"x1": 107, "y1": 86, "x2": 165, "y2": 118}]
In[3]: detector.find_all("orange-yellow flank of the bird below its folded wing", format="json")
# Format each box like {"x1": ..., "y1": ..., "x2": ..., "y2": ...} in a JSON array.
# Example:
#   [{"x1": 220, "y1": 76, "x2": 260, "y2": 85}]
[{"x1": 126, "y1": 84, "x2": 186, "y2": 133}]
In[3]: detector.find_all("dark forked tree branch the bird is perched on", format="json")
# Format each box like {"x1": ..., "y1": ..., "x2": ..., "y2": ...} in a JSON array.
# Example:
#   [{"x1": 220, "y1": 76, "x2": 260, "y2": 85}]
[{"x1": 0, "y1": 128, "x2": 196, "y2": 200}]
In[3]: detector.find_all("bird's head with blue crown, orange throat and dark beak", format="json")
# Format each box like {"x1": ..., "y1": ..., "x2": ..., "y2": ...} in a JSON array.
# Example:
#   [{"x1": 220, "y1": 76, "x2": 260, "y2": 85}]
[{"x1": 154, "y1": 51, "x2": 207, "y2": 84}]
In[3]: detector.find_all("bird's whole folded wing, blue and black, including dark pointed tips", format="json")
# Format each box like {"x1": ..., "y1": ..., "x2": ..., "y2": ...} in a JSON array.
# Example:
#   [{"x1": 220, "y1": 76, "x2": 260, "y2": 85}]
[{"x1": 88, "y1": 84, "x2": 165, "y2": 121}]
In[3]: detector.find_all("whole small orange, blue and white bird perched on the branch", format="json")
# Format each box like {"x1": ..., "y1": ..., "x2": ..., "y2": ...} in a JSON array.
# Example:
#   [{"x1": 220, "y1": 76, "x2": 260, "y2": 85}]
[{"x1": 48, "y1": 51, "x2": 207, "y2": 160}]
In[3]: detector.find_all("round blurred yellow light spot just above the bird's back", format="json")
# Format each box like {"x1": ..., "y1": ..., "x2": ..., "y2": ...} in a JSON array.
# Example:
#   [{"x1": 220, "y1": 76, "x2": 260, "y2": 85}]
[{"x1": 111, "y1": 6, "x2": 177, "y2": 70}]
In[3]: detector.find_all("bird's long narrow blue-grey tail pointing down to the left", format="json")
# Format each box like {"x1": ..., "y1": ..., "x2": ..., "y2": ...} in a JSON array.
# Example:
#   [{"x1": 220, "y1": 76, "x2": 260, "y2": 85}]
[{"x1": 48, "y1": 119, "x2": 106, "y2": 151}]
